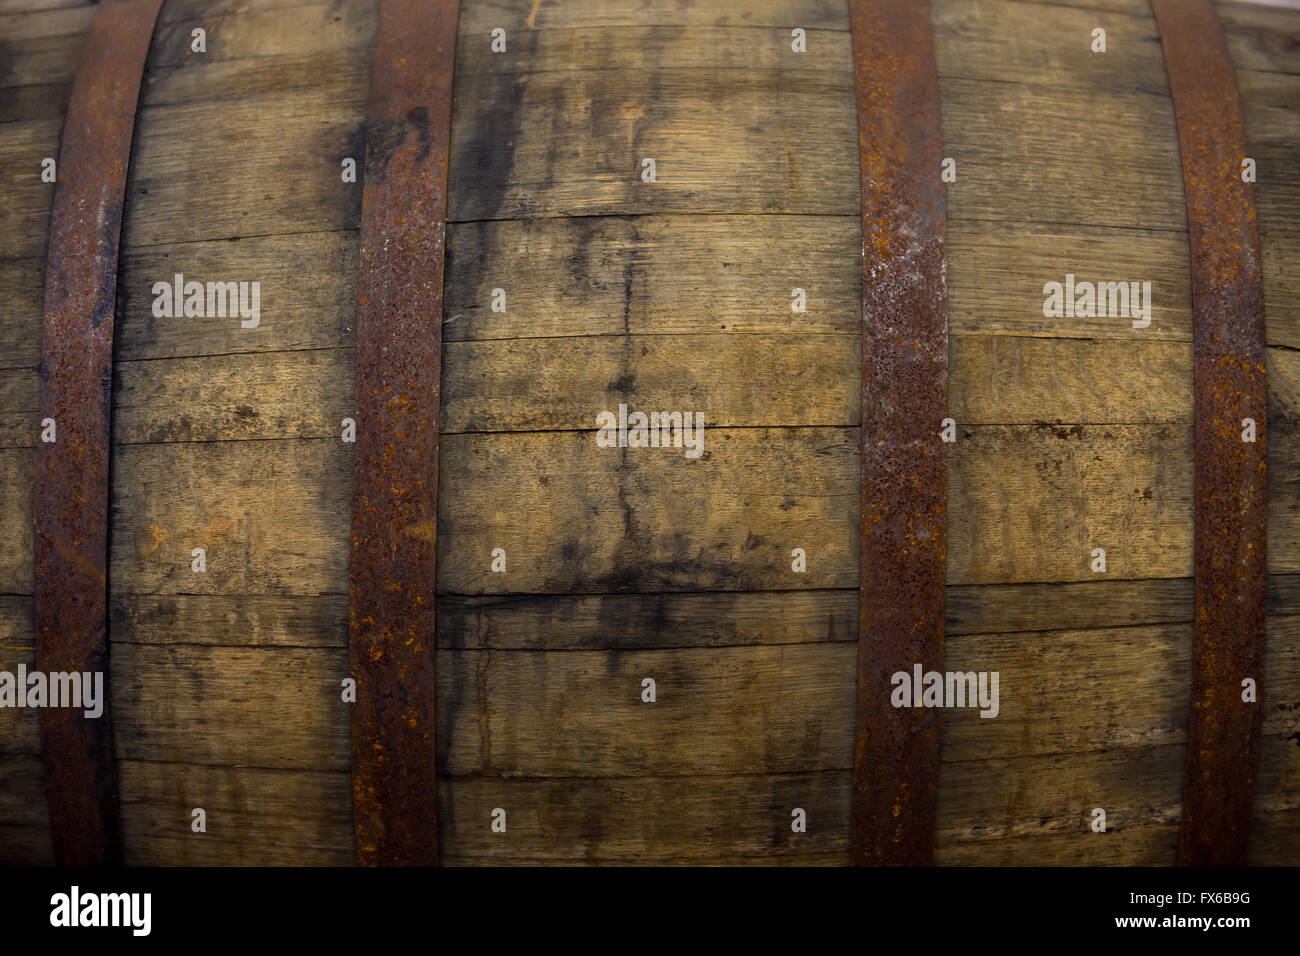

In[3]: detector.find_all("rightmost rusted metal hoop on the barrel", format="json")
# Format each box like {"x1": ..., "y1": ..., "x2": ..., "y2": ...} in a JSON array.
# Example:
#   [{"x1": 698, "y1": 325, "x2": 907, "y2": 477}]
[{"x1": 1152, "y1": 0, "x2": 1268, "y2": 866}]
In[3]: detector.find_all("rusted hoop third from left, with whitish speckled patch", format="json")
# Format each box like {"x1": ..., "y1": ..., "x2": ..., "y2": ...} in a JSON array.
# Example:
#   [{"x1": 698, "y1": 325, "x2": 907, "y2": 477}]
[{"x1": 849, "y1": 0, "x2": 948, "y2": 865}]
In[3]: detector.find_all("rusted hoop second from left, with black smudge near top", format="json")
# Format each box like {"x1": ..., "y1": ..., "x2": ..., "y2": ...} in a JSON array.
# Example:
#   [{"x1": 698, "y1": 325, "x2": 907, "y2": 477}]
[{"x1": 350, "y1": 0, "x2": 459, "y2": 866}]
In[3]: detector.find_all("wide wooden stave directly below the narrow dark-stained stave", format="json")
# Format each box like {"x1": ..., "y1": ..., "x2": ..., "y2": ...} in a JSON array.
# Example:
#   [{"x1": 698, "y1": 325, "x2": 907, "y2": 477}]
[{"x1": 104, "y1": 629, "x2": 1300, "y2": 778}]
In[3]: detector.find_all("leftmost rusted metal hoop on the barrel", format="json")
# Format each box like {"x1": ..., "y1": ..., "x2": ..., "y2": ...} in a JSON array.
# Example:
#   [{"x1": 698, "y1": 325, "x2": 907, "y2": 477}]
[{"x1": 34, "y1": 0, "x2": 161, "y2": 866}]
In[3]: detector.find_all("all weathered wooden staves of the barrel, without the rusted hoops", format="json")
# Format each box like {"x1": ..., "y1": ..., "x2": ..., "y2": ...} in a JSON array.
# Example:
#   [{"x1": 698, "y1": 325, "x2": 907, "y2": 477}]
[{"x1": 0, "y1": 0, "x2": 1300, "y2": 864}]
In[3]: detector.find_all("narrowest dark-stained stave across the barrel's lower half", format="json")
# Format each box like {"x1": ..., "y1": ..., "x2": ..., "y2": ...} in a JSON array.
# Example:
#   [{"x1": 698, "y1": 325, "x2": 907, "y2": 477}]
[{"x1": 101, "y1": 574, "x2": 1300, "y2": 650}]
